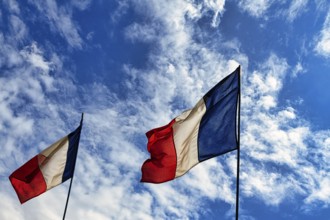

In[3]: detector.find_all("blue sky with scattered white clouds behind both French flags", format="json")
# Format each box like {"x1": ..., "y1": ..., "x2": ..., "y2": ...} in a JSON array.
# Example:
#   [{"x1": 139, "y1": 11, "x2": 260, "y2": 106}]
[{"x1": 0, "y1": 0, "x2": 330, "y2": 220}]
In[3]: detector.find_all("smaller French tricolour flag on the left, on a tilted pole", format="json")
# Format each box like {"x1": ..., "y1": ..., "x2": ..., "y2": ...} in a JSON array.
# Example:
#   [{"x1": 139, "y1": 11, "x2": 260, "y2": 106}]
[{"x1": 9, "y1": 116, "x2": 83, "y2": 204}]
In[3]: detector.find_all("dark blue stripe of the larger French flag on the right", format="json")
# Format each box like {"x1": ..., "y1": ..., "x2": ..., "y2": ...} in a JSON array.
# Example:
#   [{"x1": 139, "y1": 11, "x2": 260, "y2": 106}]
[{"x1": 198, "y1": 68, "x2": 239, "y2": 162}]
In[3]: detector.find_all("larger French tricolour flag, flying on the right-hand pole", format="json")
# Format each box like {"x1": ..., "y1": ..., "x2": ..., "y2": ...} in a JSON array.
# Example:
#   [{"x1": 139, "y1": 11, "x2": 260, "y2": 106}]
[{"x1": 141, "y1": 67, "x2": 240, "y2": 183}]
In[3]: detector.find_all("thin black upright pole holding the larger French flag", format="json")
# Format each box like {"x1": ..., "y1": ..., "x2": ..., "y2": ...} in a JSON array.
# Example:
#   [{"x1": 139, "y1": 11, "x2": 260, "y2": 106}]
[{"x1": 236, "y1": 66, "x2": 241, "y2": 220}]
